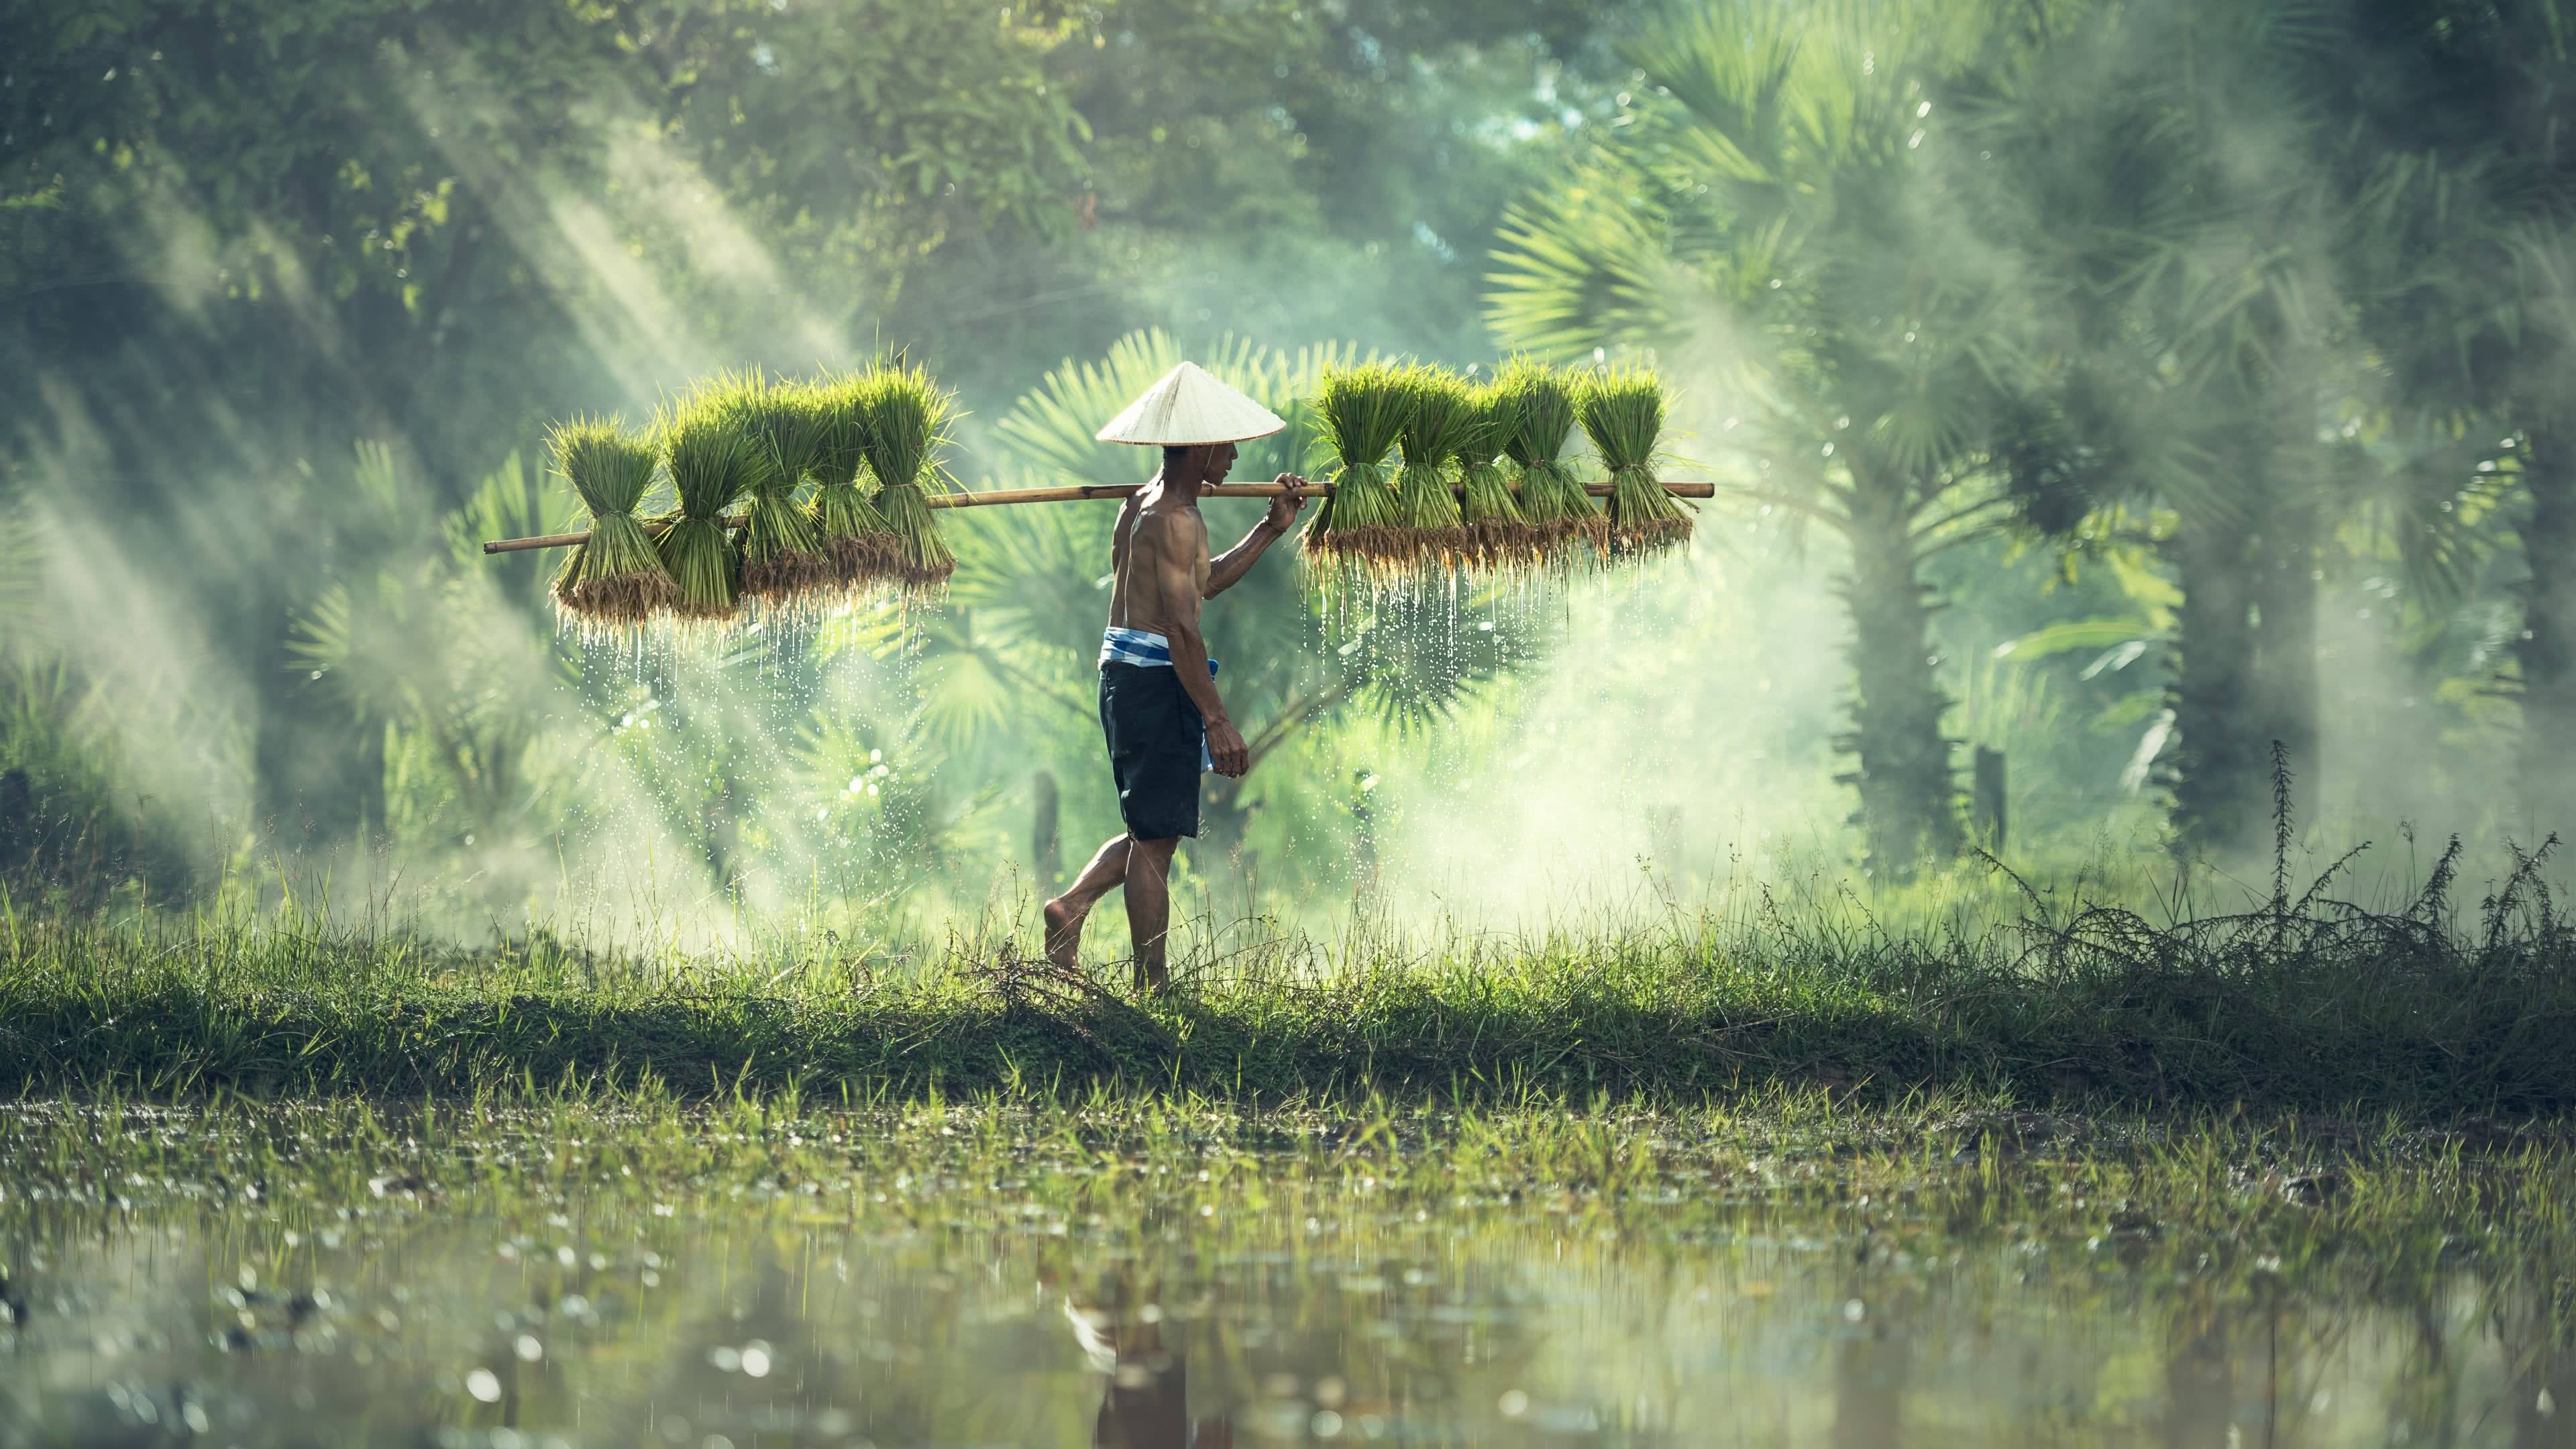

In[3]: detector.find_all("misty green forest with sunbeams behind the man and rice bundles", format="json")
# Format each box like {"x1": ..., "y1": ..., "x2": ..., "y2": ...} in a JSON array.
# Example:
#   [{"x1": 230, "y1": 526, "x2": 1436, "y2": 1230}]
[{"x1": 0, "y1": 0, "x2": 2576, "y2": 938}]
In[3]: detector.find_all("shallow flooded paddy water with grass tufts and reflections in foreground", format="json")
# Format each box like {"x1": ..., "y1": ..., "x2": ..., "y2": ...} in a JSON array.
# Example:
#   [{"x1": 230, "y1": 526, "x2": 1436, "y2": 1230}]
[{"x1": 0, "y1": 1098, "x2": 2576, "y2": 1449}]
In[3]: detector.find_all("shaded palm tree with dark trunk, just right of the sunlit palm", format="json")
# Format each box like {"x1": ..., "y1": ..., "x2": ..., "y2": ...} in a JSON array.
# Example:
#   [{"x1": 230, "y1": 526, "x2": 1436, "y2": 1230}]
[{"x1": 1978, "y1": 0, "x2": 2352, "y2": 851}]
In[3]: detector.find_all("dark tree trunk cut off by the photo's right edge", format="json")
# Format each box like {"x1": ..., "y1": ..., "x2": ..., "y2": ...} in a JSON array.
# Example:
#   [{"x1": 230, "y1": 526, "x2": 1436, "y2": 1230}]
[{"x1": 2514, "y1": 428, "x2": 2576, "y2": 835}]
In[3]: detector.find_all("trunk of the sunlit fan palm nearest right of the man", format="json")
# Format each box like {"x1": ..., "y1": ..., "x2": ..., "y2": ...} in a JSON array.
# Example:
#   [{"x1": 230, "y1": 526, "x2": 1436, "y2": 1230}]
[{"x1": 1837, "y1": 467, "x2": 1960, "y2": 881}]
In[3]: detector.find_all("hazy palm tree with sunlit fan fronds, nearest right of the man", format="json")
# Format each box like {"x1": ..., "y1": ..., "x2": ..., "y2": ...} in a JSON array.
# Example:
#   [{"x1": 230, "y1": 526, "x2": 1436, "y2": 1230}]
[{"x1": 1489, "y1": 0, "x2": 2025, "y2": 877}]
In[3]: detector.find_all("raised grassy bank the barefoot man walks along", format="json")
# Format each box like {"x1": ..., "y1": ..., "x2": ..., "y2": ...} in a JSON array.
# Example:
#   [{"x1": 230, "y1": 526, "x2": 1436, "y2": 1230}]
[{"x1": 15, "y1": 835, "x2": 2576, "y2": 1114}]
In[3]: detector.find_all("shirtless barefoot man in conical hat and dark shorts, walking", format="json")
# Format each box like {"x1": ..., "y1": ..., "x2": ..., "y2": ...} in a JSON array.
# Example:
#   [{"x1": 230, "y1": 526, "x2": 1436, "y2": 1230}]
[{"x1": 1046, "y1": 364, "x2": 1306, "y2": 990}]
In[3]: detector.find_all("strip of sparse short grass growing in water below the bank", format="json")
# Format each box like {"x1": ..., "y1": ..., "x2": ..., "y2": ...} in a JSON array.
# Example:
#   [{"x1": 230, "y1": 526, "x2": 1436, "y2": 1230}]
[{"x1": 0, "y1": 1088, "x2": 2576, "y2": 1312}]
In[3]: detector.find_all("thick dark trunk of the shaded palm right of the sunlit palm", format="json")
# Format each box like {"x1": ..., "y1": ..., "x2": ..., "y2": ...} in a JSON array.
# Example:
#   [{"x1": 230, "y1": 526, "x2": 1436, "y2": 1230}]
[{"x1": 2166, "y1": 516, "x2": 2272, "y2": 853}]
